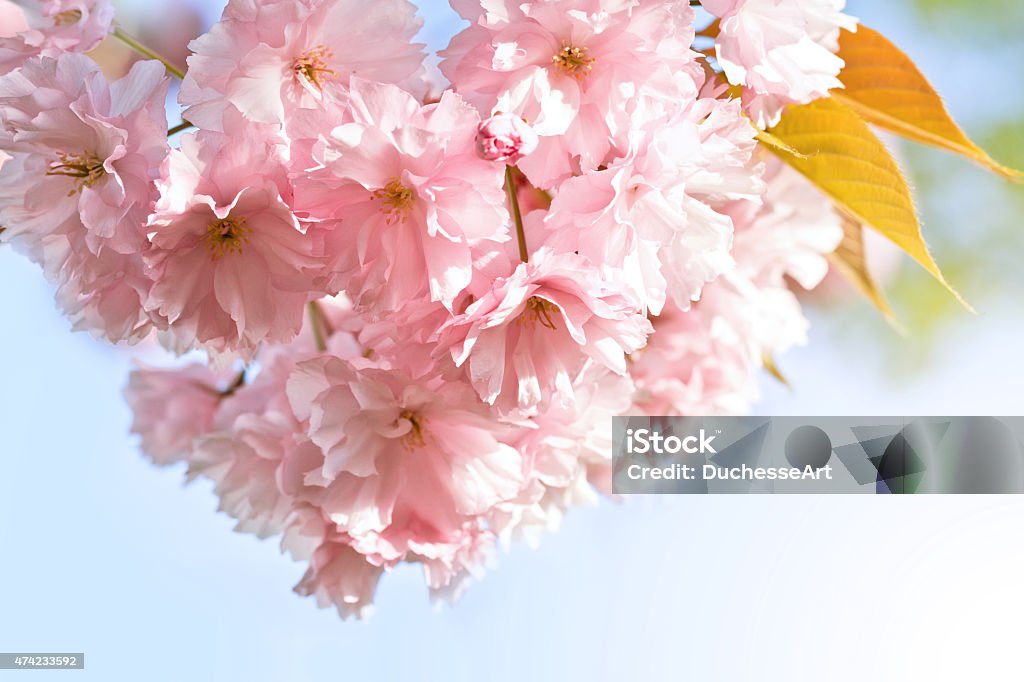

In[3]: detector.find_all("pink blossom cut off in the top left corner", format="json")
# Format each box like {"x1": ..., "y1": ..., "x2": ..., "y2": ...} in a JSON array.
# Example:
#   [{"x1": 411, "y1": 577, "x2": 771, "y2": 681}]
[{"x1": 0, "y1": 0, "x2": 114, "y2": 75}]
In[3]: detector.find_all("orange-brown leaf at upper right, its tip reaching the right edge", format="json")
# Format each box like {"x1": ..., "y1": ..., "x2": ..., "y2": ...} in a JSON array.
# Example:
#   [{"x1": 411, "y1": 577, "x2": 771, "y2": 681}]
[{"x1": 831, "y1": 26, "x2": 1022, "y2": 180}]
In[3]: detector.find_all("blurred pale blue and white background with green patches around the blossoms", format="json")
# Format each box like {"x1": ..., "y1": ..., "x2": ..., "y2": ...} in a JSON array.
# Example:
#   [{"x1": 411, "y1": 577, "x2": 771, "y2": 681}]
[{"x1": 0, "y1": 0, "x2": 1024, "y2": 682}]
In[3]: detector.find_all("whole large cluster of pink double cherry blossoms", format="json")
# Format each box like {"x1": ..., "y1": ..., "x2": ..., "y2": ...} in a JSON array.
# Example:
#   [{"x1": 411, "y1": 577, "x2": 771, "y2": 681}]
[{"x1": 0, "y1": 0, "x2": 855, "y2": 616}]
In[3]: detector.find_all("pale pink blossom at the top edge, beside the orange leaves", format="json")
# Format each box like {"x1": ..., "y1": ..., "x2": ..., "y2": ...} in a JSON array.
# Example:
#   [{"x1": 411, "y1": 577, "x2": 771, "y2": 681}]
[{"x1": 701, "y1": 0, "x2": 857, "y2": 128}]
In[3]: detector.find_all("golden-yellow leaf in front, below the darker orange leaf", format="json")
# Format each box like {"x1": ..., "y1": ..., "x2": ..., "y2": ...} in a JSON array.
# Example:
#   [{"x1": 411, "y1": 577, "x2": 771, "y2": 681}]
[{"x1": 769, "y1": 98, "x2": 971, "y2": 309}]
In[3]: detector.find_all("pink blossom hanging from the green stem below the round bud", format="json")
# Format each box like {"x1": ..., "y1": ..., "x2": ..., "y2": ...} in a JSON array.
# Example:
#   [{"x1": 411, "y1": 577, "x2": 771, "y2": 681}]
[{"x1": 438, "y1": 249, "x2": 650, "y2": 413}]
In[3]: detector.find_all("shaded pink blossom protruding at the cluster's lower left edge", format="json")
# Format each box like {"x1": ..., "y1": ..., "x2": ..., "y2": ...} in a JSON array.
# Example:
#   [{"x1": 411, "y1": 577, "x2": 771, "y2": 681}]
[{"x1": 125, "y1": 365, "x2": 232, "y2": 466}]
